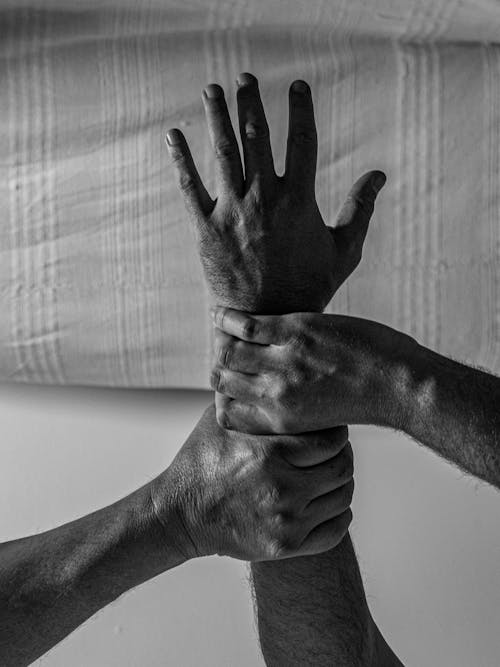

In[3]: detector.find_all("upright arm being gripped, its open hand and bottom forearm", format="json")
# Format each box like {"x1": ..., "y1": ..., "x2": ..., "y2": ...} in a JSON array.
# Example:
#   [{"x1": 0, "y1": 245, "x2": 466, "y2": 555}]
[{"x1": 167, "y1": 73, "x2": 401, "y2": 667}]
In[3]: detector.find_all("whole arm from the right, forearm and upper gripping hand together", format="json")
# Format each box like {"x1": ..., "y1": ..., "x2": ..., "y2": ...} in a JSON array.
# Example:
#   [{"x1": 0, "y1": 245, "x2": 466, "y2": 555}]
[{"x1": 212, "y1": 308, "x2": 500, "y2": 488}]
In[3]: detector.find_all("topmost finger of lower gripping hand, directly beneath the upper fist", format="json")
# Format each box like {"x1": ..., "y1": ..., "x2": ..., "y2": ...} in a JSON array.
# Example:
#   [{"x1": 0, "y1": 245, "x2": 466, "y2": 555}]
[{"x1": 278, "y1": 428, "x2": 352, "y2": 473}]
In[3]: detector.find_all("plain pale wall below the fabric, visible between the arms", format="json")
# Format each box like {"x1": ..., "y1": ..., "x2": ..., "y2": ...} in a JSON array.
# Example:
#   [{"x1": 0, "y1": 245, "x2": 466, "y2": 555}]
[{"x1": 0, "y1": 385, "x2": 500, "y2": 667}]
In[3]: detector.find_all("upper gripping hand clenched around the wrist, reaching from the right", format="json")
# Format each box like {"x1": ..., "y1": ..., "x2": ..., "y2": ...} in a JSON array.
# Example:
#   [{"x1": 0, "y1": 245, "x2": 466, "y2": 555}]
[{"x1": 210, "y1": 308, "x2": 417, "y2": 434}]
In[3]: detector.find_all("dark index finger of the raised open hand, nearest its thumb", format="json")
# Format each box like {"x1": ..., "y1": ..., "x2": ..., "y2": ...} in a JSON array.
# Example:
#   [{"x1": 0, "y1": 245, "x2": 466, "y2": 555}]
[{"x1": 284, "y1": 80, "x2": 318, "y2": 196}]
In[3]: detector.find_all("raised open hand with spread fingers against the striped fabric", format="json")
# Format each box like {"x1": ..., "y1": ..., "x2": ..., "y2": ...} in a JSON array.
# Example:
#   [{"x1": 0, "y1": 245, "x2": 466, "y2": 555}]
[{"x1": 167, "y1": 73, "x2": 385, "y2": 314}]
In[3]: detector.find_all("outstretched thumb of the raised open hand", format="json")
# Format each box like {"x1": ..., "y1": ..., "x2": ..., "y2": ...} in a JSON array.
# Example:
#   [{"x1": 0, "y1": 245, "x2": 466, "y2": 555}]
[{"x1": 333, "y1": 171, "x2": 386, "y2": 254}]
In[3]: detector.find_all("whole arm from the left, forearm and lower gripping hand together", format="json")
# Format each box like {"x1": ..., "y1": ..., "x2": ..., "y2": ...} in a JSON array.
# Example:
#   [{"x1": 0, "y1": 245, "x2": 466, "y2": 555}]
[{"x1": 0, "y1": 404, "x2": 353, "y2": 667}]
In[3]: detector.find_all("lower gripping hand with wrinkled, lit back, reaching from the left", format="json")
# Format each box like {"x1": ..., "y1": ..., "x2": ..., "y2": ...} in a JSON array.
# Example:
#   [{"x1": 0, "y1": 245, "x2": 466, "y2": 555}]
[{"x1": 148, "y1": 404, "x2": 354, "y2": 561}]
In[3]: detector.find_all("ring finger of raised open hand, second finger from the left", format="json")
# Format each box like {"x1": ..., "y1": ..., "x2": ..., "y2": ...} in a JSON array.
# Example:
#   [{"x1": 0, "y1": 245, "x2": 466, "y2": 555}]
[{"x1": 202, "y1": 83, "x2": 244, "y2": 197}]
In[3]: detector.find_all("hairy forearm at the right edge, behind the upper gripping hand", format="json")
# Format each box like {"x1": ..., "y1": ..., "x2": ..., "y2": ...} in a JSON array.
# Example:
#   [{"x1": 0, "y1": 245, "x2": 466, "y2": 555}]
[{"x1": 393, "y1": 346, "x2": 500, "y2": 488}]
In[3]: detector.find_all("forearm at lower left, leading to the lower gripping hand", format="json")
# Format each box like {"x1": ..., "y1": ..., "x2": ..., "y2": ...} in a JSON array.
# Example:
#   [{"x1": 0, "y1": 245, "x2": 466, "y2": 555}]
[{"x1": 0, "y1": 485, "x2": 185, "y2": 667}]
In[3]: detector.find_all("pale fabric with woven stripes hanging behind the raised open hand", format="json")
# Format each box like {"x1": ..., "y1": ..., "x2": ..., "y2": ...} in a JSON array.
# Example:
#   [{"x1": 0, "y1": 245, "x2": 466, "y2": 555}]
[{"x1": 0, "y1": 0, "x2": 500, "y2": 387}]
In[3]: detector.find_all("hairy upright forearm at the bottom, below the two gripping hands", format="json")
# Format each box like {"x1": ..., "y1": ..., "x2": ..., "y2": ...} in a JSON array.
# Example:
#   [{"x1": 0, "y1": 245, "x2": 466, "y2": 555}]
[{"x1": 252, "y1": 535, "x2": 376, "y2": 667}]
